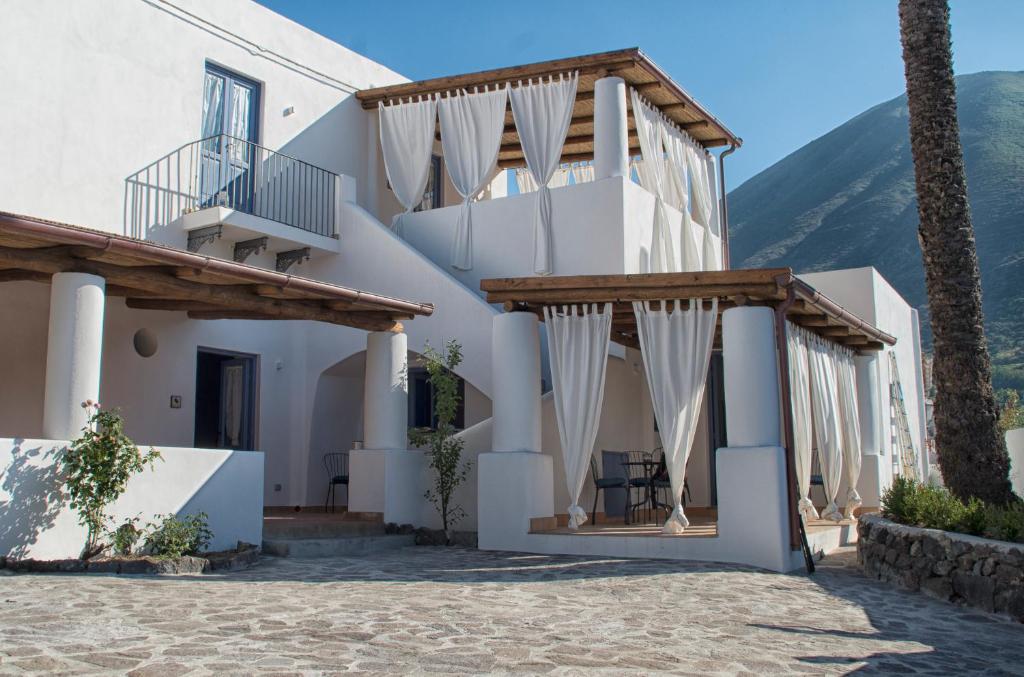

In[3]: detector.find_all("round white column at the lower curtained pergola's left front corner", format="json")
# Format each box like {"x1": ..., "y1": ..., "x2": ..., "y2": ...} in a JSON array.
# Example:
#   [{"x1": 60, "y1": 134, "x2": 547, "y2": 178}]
[{"x1": 490, "y1": 312, "x2": 541, "y2": 452}]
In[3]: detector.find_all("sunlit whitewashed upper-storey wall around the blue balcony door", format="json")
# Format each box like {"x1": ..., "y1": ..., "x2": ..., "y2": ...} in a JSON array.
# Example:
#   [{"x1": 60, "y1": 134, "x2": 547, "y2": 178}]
[{"x1": 0, "y1": 0, "x2": 404, "y2": 231}]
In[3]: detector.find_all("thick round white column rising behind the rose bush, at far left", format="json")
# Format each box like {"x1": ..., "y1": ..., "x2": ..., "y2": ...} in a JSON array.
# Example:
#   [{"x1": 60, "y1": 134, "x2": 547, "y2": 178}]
[{"x1": 43, "y1": 272, "x2": 105, "y2": 439}]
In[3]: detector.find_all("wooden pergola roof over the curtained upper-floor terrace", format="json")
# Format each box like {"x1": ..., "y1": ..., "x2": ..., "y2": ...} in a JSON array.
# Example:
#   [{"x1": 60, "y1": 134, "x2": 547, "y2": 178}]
[{"x1": 355, "y1": 47, "x2": 742, "y2": 168}]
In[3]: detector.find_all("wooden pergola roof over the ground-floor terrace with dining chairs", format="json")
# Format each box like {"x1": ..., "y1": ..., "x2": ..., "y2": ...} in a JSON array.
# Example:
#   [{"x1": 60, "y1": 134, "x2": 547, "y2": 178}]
[{"x1": 480, "y1": 268, "x2": 896, "y2": 352}]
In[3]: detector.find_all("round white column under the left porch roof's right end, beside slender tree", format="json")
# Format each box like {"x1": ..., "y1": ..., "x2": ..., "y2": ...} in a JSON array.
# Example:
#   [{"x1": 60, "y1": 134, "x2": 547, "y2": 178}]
[{"x1": 362, "y1": 332, "x2": 409, "y2": 450}]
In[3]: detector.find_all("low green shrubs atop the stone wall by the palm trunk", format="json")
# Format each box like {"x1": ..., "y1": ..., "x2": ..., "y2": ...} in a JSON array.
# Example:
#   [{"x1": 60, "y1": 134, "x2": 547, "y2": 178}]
[{"x1": 882, "y1": 477, "x2": 1024, "y2": 543}]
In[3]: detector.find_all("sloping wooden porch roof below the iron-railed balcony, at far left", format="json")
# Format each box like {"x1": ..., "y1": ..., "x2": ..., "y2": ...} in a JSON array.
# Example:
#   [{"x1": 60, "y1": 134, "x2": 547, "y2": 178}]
[{"x1": 0, "y1": 212, "x2": 434, "y2": 331}]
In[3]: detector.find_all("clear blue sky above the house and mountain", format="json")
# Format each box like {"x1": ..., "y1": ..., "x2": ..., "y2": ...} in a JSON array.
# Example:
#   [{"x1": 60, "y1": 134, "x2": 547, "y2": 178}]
[{"x1": 258, "y1": 0, "x2": 1024, "y2": 187}]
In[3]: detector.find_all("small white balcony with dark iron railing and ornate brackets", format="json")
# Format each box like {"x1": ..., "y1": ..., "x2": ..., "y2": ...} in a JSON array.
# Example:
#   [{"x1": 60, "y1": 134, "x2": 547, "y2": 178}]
[{"x1": 125, "y1": 135, "x2": 354, "y2": 271}]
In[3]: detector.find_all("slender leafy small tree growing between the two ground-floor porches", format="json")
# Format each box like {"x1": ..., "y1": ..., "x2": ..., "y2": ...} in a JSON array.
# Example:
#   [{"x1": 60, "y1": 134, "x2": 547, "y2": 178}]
[{"x1": 409, "y1": 339, "x2": 470, "y2": 533}]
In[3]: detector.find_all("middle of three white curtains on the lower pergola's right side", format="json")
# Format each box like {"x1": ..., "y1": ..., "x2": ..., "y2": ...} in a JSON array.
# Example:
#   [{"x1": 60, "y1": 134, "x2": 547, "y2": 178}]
[{"x1": 808, "y1": 334, "x2": 843, "y2": 521}]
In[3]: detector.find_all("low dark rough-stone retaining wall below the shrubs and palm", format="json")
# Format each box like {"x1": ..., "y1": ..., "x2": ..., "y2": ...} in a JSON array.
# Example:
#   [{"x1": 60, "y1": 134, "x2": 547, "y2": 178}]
[{"x1": 857, "y1": 514, "x2": 1024, "y2": 623}]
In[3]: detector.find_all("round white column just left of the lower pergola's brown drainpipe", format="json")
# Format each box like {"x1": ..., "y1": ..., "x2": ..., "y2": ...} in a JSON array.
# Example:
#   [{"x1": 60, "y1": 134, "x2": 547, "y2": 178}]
[{"x1": 722, "y1": 306, "x2": 782, "y2": 447}]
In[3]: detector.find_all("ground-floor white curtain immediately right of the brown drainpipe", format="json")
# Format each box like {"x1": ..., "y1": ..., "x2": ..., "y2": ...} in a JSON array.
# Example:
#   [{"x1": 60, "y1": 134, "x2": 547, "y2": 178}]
[{"x1": 785, "y1": 322, "x2": 818, "y2": 521}]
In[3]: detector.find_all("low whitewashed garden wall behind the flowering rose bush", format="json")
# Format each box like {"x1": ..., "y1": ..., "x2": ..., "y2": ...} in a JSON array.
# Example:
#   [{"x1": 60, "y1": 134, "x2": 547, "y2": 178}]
[{"x1": 0, "y1": 438, "x2": 263, "y2": 559}]
